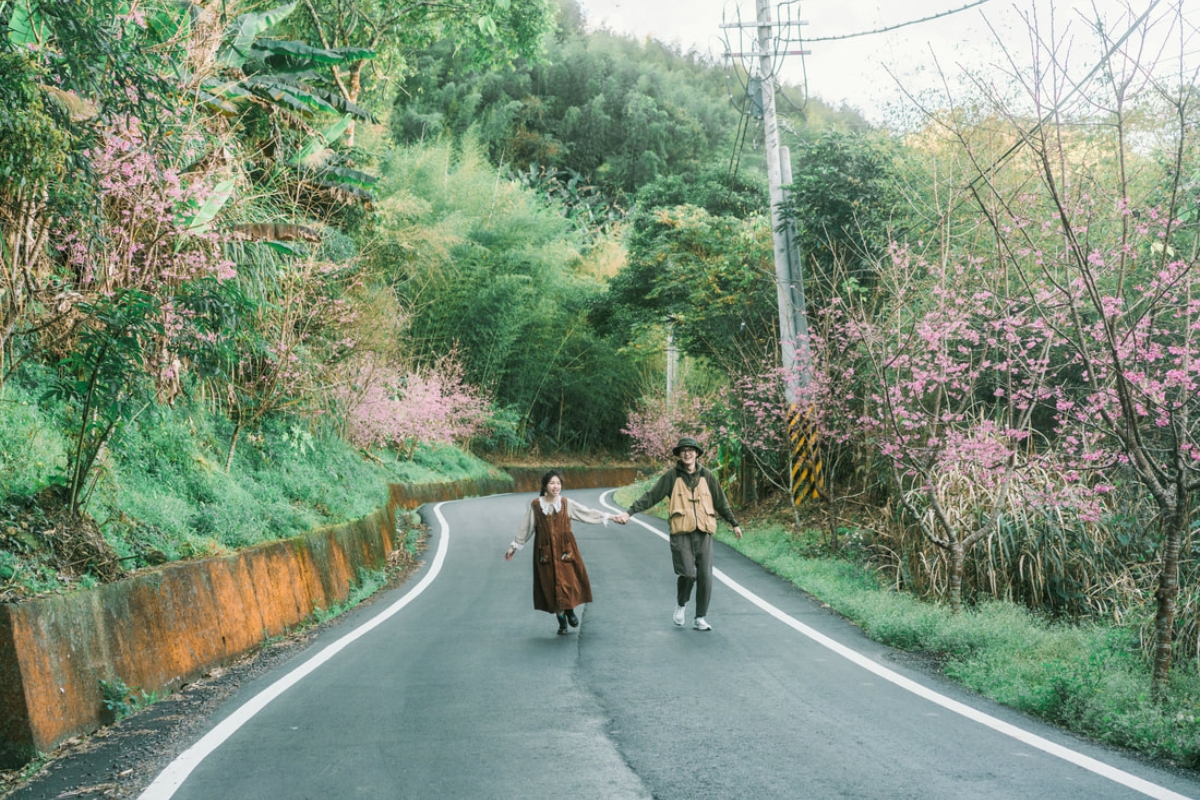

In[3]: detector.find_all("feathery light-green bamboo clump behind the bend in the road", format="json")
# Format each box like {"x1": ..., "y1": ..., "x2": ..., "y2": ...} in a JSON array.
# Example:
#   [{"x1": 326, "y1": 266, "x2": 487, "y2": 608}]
[{"x1": 370, "y1": 144, "x2": 632, "y2": 449}]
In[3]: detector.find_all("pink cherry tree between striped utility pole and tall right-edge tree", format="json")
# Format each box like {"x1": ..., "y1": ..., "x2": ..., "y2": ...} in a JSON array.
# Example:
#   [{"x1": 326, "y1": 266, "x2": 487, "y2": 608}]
[{"x1": 815, "y1": 246, "x2": 1094, "y2": 610}]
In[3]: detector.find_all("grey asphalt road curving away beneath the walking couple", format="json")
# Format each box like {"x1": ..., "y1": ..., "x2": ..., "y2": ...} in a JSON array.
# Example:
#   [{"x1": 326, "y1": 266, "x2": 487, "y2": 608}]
[{"x1": 131, "y1": 487, "x2": 1200, "y2": 800}]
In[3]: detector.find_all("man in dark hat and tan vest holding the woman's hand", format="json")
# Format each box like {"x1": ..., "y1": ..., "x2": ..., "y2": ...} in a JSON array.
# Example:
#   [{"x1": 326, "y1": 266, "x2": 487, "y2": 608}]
[{"x1": 617, "y1": 437, "x2": 742, "y2": 631}]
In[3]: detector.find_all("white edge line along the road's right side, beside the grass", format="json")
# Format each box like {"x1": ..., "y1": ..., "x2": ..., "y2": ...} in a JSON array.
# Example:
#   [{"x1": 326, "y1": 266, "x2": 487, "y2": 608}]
[{"x1": 600, "y1": 491, "x2": 1192, "y2": 800}]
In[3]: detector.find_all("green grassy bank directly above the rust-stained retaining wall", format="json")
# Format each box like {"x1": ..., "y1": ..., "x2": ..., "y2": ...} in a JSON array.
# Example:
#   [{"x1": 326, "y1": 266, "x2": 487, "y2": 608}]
[{"x1": 0, "y1": 374, "x2": 499, "y2": 600}]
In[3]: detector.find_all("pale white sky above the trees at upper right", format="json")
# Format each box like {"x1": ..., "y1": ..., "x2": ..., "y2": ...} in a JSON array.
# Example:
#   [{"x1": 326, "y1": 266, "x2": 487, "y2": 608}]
[{"x1": 578, "y1": 0, "x2": 1200, "y2": 122}]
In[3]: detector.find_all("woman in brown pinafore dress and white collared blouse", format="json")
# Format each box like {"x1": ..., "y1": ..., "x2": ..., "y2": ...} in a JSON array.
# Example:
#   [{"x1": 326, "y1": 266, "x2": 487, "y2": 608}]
[{"x1": 504, "y1": 469, "x2": 624, "y2": 636}]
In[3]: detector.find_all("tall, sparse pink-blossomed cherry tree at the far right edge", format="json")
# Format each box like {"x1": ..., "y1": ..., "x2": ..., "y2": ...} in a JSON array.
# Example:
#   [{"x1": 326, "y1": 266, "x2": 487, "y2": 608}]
[{"x1": 967, "y1": 4, "x2": 1200, "y2": 693}]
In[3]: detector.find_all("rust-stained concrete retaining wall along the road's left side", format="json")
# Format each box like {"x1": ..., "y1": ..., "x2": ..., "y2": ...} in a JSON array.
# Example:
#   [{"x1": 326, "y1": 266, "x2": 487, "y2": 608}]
[{"x1": 0, "y1": 468, "x2": 635, "y2": 769}]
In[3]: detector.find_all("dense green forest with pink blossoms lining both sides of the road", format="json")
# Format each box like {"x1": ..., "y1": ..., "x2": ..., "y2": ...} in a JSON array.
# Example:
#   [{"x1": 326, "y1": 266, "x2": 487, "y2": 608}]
[{"x1": 0, "y1": 0, "x2": 1200, "y2": 734}]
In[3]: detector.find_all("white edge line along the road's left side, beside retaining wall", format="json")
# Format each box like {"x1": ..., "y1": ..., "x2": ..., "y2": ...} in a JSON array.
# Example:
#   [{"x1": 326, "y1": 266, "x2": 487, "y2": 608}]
[{"x1": 138, "y1": 503, "x2": 450, "y2": 800}]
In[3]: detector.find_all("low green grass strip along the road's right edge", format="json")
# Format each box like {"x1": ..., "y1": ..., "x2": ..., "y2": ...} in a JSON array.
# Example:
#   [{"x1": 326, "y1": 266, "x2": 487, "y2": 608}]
[{"x1": 614, "y1": 483, "x2": 1200, "y2": 769}]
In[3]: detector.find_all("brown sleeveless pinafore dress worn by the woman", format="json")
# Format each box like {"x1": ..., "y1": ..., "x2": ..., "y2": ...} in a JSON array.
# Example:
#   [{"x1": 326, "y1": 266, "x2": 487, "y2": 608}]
[{"x1": 533, "y1": 498, "x2": 592, "y2": 614}]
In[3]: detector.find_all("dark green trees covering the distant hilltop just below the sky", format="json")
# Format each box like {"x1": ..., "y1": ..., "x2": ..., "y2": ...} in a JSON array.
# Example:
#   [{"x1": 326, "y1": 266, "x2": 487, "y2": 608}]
[{"x1": 392, "y1": 22, "x2": 737, "y2": 197}]
